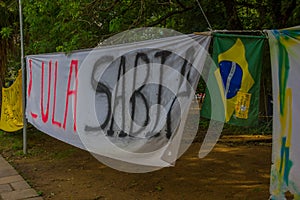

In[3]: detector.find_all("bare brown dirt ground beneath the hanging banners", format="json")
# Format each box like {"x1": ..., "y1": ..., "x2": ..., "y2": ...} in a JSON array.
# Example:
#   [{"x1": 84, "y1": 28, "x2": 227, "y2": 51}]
[{"x1": 3, "y1": 134, "x2": 271, "y2": 200}]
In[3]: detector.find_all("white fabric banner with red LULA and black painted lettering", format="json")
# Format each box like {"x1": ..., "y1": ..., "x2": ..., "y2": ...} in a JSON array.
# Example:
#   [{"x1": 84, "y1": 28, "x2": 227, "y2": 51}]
[{"x1": 26, "y1": 35, "x2": 211, "y2": 170}]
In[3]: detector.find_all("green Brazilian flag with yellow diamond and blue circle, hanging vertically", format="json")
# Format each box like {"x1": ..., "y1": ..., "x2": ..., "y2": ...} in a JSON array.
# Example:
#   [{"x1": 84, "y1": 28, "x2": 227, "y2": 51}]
[{"x1": 201, "y1": 33, "x2": 266, "y2": 126}]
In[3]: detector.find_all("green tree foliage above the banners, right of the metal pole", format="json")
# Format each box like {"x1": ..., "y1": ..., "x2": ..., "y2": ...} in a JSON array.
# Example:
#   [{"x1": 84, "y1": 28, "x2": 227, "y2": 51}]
[{"x1": 18, "y1": 0, "x2": 300, "y2": 54}]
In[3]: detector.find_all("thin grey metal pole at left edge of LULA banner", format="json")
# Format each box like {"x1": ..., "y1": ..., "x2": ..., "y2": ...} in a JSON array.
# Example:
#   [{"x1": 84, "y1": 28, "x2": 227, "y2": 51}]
[{"x1": 19, "y1": 0, "x2": 27, "y2": 154}]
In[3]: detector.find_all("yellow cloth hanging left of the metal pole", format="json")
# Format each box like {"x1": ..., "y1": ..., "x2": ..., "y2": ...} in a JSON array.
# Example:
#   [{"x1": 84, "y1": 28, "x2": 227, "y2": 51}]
[{"x1": 0, "y1": 71, "x2": 23, "y2": 132}]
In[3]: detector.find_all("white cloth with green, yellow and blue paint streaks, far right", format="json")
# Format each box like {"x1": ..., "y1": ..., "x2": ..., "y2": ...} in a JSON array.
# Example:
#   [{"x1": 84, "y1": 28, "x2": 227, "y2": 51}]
[{"x1": 268, "y1": 26, "x2": 300, "y2": 199}]
